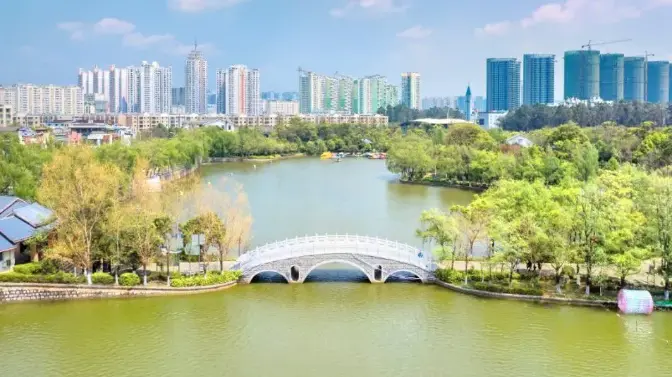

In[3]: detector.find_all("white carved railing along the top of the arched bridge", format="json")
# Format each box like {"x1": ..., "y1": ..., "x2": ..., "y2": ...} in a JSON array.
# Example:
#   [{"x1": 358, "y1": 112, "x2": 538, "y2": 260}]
[{"x1": 234, "y1": 234, "x2": 435, "y2": 271}]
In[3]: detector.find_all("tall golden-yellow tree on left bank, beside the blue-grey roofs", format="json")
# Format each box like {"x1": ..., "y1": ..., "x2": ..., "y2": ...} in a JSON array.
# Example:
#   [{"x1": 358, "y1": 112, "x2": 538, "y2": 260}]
[{"x1": 38, "y1": 147, "x2": 122, "y2": 284}]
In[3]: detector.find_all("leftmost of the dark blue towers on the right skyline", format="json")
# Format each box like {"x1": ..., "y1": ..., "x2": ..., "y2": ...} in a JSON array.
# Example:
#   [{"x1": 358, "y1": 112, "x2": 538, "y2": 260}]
[{"x1": 486, "y1": 58, "x2": 520, "y2": 112}]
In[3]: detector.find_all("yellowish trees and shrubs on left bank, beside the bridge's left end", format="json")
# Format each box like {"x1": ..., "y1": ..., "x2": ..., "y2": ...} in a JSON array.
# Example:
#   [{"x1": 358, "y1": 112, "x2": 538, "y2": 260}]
[{"x1": 0, "y1": 146, "x2": 252, "y2": 286}]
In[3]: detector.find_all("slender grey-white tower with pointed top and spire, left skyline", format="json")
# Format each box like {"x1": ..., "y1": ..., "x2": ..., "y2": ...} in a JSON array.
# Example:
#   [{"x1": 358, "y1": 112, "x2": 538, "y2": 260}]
[{"x1": 184, "y1": 45, "x2": 208, "y2": 114}]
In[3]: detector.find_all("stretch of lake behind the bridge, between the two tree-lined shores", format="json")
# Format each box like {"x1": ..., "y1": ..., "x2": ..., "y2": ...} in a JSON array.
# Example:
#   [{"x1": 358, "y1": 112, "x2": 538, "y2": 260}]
[{"x1": 202, "y1": 158, "x2": 474, "y2": 250}]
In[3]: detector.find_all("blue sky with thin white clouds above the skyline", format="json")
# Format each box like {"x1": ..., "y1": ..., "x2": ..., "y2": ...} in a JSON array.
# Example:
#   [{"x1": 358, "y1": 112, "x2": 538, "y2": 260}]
[{"x1": 0, "y1": 0, "x2": 672, "y2": 96}]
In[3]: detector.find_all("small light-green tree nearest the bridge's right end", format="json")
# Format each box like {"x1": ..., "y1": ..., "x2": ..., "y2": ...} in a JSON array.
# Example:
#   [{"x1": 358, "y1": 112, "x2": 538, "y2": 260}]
[{"x1": 416, "y1": 209, "x2": 457, "y2": 270}]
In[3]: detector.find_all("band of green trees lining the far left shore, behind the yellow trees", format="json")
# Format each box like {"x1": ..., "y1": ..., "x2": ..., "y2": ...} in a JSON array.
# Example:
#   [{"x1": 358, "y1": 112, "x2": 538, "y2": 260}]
[{"x1": 0, "y1": 119, "x2": 401, "y2": 200}]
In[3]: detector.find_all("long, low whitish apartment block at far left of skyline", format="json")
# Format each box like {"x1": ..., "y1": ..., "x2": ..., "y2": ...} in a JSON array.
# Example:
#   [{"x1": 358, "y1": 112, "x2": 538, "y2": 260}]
[{"x1": 3, "y1": 84, "x2": 83, "y2": 116}]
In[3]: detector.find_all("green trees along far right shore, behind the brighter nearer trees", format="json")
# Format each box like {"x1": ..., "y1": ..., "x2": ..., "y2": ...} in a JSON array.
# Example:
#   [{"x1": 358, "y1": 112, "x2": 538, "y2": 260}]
[{"x1": 387, "y1": 123, "x2": 672, "y2": 187}]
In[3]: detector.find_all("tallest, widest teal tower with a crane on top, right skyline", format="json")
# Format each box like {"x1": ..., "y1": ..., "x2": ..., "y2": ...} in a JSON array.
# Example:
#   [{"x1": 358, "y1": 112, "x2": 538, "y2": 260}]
[{"x1": 565, "y1": 50, "x2": 600, "y2": 100}]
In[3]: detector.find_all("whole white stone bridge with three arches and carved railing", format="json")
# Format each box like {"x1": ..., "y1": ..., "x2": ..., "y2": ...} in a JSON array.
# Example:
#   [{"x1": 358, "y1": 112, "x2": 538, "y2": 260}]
[{"x1": 232, "y1": 235, "x2": 436, "y2": 283}]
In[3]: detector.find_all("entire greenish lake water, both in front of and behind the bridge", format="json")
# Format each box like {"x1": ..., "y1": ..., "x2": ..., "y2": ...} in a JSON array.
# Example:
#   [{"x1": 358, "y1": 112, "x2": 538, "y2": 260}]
[{"x1": 0, "y1": 159, "x2": 672, "y2": 377}]
